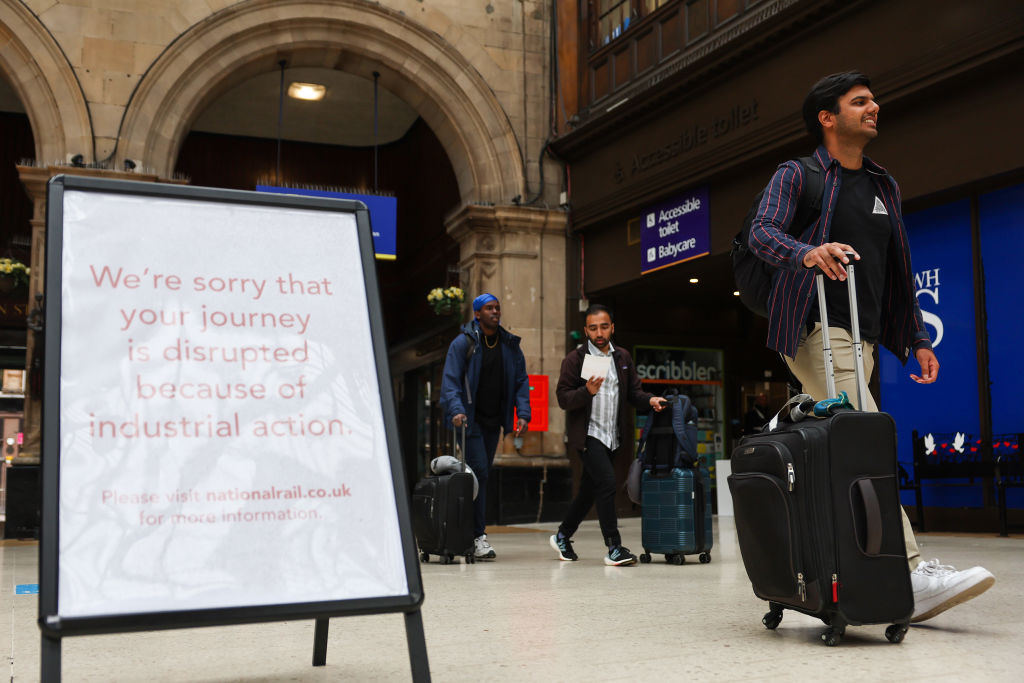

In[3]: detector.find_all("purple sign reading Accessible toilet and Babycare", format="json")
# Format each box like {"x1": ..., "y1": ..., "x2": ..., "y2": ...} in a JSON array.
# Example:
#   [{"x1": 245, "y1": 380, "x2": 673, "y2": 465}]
[{"x1": 640, "y1": 185, "x2": 711, "y2": 273}]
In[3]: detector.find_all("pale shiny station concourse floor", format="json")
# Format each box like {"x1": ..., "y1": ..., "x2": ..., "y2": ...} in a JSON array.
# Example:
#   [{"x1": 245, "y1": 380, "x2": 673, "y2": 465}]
[{"x1": 0, "y1": 517, "x2": 1024, "y2": 683}]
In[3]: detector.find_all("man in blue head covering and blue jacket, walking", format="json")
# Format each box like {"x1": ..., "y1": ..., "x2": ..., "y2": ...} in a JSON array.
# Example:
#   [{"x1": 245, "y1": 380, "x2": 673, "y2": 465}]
[{"x1": 441, "y1": 294, "x2": 529, "y2": 559}]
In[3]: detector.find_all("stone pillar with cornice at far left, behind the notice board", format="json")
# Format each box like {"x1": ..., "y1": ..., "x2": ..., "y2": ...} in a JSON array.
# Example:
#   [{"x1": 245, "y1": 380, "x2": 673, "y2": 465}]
[{"x1": 14, "y1": 166, "x2": 180, "y2": 464}]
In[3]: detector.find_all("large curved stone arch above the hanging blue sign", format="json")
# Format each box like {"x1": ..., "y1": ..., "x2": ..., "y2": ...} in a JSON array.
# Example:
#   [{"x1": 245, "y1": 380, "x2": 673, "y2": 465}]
[{"x1": 116, "y1": 0, "x2": 522, "y2": 204}]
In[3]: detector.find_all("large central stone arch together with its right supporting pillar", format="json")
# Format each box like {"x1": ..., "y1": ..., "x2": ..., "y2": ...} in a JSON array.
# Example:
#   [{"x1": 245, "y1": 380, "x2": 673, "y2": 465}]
[{"x1": 113, "y1": 0, "x2": 566, "y2": 464}]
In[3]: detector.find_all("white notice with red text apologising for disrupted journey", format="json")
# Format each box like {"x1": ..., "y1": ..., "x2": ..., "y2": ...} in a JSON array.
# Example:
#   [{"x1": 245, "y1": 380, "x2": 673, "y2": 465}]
[{"x1": 57, "y1": 190, "x2": 408, "y2": 616}]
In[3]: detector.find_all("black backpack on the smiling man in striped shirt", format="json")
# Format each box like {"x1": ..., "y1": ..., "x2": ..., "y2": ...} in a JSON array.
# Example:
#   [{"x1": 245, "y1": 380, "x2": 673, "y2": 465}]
[{"x1": 731, "y1": 157, "x2": 825, "y2": 317}]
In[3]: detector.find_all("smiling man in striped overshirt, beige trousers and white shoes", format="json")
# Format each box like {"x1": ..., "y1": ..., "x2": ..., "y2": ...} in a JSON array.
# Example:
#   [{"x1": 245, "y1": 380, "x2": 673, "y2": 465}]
[{"x1": 749, "y1": 72, "x2": 995, "y2": 622}]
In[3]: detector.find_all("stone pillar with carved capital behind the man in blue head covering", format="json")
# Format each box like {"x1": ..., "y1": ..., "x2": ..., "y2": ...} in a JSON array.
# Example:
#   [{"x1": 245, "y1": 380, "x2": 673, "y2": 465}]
[{"x1": 445, "y1": 205, "x2": 567, "y2": 466}]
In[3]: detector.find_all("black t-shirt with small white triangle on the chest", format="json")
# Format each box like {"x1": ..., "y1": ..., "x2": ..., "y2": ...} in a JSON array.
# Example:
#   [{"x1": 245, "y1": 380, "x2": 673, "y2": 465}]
[{"x1": 808, "y1": 168, "x2": 892, "y2": 343}]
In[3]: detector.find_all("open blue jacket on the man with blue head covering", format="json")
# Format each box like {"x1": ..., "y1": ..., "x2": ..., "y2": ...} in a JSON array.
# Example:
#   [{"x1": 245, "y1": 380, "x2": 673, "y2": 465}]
[{"x1": 441, "y1": 321, "x2": 529, "y2": 434}]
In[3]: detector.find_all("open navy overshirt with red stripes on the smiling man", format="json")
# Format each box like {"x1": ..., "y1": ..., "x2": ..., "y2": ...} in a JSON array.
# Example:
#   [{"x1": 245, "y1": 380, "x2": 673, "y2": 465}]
[{"x1": 750, "y1": 145, "x2": 931, "y2": 364}]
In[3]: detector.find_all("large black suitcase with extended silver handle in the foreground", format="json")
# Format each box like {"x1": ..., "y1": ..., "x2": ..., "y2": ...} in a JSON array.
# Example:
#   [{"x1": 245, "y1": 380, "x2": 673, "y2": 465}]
[{"x1": 729, "y1": 265, "x2": 913, "y2": 645}]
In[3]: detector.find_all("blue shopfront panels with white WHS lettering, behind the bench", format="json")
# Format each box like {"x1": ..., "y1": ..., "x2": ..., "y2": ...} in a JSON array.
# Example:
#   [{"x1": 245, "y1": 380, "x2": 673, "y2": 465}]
[{"x1": 880, "y1": 184, "x2": 1024, "y2": 508}]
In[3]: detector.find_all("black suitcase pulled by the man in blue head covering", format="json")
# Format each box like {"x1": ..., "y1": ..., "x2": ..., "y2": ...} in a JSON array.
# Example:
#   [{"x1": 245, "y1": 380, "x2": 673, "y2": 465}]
[{"x1": 413, "y1": 425, "x2": 476, "y2": 564}]
